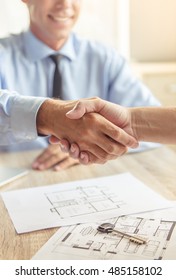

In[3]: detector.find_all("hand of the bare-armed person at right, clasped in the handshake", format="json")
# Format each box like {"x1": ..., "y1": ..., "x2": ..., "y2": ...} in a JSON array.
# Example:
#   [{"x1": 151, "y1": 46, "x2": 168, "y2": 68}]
[{"x1": 56, "y1": 98, "x2": 138, "y2": 164}]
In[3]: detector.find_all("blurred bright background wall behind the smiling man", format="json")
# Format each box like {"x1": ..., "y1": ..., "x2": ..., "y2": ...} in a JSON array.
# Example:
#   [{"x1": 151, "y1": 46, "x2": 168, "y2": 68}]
[{"x1": 0, "y1": 0, "x2": 176, "y2": 105}]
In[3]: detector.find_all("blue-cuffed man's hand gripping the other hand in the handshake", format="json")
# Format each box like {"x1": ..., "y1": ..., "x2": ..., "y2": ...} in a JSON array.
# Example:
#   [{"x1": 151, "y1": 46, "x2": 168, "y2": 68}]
[{"x1": 37, "y1": 99, "x2": 137, "y2": 163}]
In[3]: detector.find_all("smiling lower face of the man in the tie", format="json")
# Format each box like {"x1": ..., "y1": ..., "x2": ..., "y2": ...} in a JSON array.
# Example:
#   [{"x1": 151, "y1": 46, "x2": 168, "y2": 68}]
[{"x1": 22, "y1": 0, "x2": 81, "y2": 50}]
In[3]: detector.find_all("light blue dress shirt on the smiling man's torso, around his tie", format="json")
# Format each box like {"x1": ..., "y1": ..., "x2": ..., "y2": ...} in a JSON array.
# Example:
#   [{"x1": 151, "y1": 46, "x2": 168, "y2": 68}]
[{"x1": 0, "y1": 31, "x2": 160, "y2": 150}]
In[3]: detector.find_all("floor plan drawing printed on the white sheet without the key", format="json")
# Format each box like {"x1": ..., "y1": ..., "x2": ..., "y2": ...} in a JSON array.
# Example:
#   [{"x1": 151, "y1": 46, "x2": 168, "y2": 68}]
[{"x1": 45, "y1": 186, "x2": 126, "y2": 218}]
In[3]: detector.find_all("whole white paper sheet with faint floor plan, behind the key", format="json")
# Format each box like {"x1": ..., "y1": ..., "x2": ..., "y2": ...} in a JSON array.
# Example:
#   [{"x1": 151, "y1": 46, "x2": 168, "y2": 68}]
[{"x1": 2, "y1": 173, "x2": 171, "y2": 233}]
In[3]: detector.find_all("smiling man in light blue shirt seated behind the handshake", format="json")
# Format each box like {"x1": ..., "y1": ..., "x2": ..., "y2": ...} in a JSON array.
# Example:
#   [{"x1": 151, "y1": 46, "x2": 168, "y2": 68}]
[{"x1": 0, "y1": 0, "x2": 159, "y2": 170}]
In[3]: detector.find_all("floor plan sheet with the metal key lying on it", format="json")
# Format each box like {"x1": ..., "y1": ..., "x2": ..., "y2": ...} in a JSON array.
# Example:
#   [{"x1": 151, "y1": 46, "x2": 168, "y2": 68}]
[{"x1": 33, "y1": 208, "x2": 176, "y2": 260}]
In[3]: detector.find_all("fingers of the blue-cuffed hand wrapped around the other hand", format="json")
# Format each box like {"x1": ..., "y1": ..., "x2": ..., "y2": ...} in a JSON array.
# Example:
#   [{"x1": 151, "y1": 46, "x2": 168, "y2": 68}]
[{"x1": 75, "y1": 113, "x2": 138, "y2": 160}]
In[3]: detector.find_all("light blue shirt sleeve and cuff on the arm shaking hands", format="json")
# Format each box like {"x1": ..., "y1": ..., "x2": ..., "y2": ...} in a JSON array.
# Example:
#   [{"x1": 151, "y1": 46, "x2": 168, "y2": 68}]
[{"x1": 0, "y1": 90, "x2": 45, "y2": 145}]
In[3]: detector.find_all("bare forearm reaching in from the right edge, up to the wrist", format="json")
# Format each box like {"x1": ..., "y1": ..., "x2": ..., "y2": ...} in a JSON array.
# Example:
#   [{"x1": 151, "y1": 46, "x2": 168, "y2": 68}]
[{"x1": 129, "y1": 107, "x2": 176, "y2": 144}]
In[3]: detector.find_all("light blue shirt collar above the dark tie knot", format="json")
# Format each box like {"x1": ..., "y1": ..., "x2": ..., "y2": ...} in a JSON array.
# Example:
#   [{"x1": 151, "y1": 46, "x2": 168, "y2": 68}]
[{"x1": 24, "y1": 30, "x2": 77, "y2": 61}]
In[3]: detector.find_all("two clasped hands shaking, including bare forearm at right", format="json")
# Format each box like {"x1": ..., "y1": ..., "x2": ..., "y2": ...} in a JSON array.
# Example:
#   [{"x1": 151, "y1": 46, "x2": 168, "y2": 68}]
[{"x1": 37, "y1": 97, "x2": 176, "y2": 164}]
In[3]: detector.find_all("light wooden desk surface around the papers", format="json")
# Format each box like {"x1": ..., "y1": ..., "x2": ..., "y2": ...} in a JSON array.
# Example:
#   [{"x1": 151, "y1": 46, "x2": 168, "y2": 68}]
[{"x1": 0, "y1": 146, "x2": 176, "y2": 259}]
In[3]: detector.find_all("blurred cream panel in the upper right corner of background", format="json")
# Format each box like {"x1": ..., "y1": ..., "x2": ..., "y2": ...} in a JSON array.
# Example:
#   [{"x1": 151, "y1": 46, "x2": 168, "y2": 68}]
[{"x1": 129, "y1": 0, "x2": 176, "y2": 61}]
